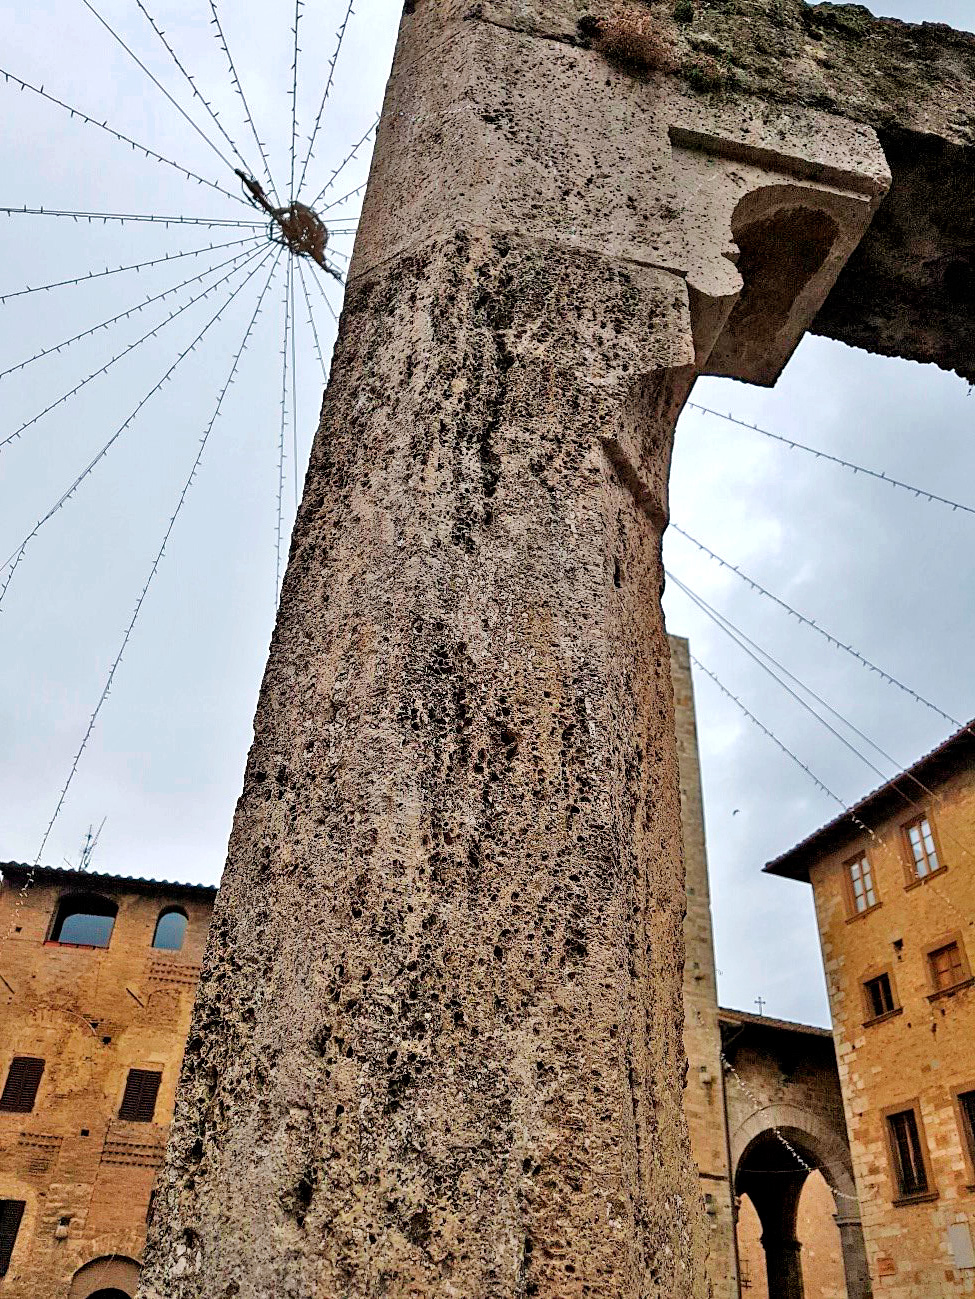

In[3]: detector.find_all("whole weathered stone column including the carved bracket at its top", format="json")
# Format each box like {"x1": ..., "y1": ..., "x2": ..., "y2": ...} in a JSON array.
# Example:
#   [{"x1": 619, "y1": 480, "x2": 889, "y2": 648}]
[{"x1": 142, "y1": 0, "x2": 884, "y2": 1299}]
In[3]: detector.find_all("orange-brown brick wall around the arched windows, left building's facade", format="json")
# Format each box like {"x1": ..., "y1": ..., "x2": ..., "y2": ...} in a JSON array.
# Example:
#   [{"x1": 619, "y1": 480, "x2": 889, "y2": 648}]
[{"x1": 0, "y1": 866, "x2": 213, "y2": 1299}]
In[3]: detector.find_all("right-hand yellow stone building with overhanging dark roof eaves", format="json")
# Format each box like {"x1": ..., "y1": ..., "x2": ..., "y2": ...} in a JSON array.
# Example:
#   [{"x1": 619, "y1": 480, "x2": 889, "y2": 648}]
[{"x1": 765, "y1": 725, "x2": 975, "y2": 1299}]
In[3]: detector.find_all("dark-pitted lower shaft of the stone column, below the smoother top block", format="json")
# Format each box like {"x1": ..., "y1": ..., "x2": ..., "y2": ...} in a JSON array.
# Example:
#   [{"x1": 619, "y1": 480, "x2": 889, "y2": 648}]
[{"x1": 143, "y1": 236, "x2": 697, "y2": 1299}]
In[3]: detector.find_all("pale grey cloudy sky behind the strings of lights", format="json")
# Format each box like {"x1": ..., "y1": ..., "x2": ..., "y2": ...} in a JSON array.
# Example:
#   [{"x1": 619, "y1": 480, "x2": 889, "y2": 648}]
[{"x1": 0, "y1": 0, "x2": 975, "y2": 1022}]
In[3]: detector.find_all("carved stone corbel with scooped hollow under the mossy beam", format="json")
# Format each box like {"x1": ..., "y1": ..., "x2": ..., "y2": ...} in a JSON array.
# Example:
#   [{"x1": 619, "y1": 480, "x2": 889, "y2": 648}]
[{"x1": 669, "y1": 100, "x2": 891, "y2": 386}]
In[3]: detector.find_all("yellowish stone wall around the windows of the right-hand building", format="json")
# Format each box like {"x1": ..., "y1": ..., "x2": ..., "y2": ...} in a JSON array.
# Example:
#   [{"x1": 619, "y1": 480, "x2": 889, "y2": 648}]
[{"x1": 810, "y1": 766, "x2": 975, "y2": 1299}]
